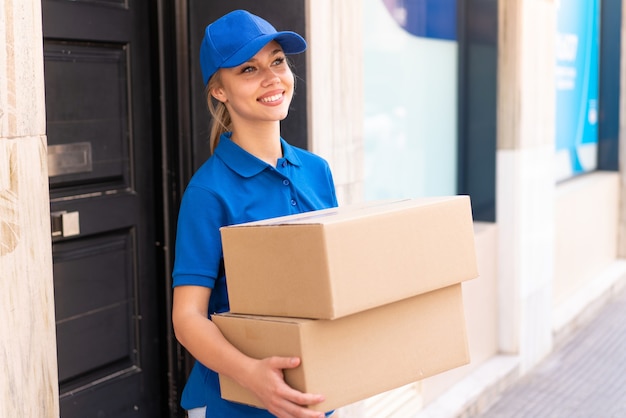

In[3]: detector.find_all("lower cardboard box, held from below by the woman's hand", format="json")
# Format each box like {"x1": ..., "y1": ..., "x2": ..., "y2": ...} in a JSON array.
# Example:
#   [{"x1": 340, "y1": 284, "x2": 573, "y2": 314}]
[{"x1": 213, "y1": 283, "x2": 469, "y2": 411}]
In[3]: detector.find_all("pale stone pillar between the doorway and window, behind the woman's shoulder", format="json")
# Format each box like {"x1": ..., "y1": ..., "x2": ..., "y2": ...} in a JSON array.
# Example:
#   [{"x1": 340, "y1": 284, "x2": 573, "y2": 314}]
[{"x1": 306, "y1": 0, "x2": 364, "y2": 204}]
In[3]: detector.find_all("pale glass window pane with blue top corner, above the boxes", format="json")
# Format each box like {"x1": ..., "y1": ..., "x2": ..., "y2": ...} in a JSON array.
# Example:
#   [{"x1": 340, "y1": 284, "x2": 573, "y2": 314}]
[{"x1": 363, "y1": 0, "x2": 458, "y2": 200}]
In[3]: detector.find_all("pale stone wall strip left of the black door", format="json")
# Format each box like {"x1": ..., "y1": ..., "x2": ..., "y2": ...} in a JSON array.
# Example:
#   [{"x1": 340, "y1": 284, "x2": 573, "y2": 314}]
[{"x1": 0, "y1": 0, "x2": 59, "y2": 418}]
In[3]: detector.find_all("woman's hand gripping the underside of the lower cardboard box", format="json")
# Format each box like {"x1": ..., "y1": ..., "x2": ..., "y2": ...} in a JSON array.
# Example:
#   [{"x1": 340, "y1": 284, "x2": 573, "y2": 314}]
[{"x1": 247, "y1": 357, "x2": 325, "y2": 418}]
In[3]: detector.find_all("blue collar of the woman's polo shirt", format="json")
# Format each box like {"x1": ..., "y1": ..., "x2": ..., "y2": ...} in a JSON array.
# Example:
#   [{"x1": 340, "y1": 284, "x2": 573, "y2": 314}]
[{"x1": 215, "y1": 132, "x2": 301, "y2": 177}]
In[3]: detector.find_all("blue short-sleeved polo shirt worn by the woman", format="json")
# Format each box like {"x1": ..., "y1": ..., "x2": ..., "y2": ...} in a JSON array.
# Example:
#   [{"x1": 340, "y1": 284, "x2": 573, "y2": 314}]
[{"x1": 172, "y1": 133, "x2": 337, "y2": 418}]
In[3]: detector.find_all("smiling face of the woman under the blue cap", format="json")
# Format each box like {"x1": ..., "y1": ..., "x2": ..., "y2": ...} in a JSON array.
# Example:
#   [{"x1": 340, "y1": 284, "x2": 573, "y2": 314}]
[{"x1": 211, "y1": 41, "x2": 294, "y2": 126}]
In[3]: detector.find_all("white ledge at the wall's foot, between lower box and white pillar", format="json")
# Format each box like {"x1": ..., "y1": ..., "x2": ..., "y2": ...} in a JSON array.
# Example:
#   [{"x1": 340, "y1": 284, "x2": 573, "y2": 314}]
[{"x1": 413, "y1": 355, "x2": 520, "y2": 418}]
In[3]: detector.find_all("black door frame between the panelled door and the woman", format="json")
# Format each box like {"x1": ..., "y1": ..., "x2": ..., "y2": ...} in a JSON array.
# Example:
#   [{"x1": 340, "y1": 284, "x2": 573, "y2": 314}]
[{"x1": 152, "y1": 0, "x2": 193, "y2": 418}]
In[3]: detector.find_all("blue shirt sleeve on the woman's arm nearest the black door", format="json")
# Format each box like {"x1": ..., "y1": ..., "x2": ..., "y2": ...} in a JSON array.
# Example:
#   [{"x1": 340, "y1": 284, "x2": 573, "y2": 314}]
[{"x1": 172, "y1": 186, "x2": 225, "y2": 288}]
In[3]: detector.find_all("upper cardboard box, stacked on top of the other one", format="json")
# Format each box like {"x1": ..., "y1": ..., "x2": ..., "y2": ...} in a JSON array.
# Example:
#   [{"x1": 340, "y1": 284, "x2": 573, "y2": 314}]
[{"x1": 221, "y1": 196, "x2": 478, "y2": 319}]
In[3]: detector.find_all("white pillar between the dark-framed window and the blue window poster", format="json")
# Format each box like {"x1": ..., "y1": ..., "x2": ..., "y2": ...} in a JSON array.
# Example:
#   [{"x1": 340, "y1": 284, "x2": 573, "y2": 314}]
[{"x1": 496, "y1": 0, "x2": 556, "y2": 372}]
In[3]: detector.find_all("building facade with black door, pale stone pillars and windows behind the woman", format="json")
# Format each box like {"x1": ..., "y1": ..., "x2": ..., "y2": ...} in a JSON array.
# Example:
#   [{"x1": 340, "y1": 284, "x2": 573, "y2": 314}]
[{"x1": 0, "y1": 0, "x2": 626, "y2": 417}]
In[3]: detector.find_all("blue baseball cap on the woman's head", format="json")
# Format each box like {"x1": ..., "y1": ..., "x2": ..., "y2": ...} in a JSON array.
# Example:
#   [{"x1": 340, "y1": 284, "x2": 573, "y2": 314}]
[{"x1": 200, "y1": 10, "x2": 306, "y2": 85}]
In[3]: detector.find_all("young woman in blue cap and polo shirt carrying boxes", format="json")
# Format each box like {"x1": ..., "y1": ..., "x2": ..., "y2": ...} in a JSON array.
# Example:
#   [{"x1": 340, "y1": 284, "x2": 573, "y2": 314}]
[{"x1": 172, "y1": 10, "x2": 337, "y2": 418}]
